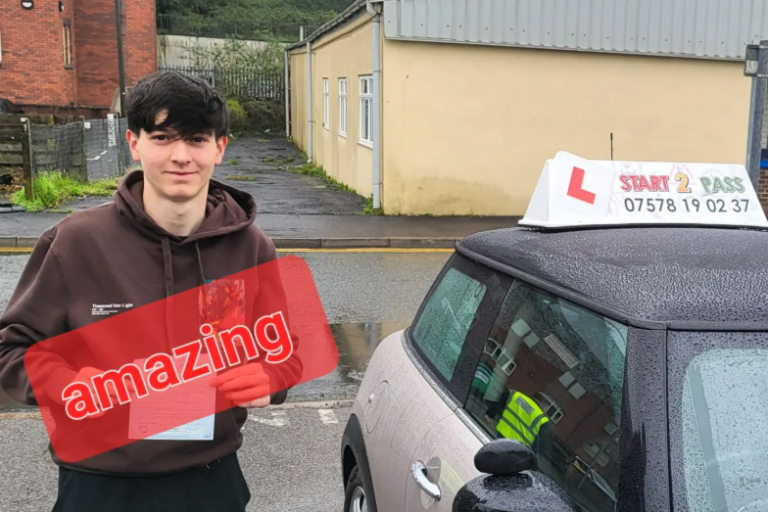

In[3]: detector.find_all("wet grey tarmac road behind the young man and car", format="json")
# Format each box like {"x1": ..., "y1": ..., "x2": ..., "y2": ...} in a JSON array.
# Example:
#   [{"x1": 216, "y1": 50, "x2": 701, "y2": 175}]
[{"x1": 0, "y1": 253, "x2": 450, "y2": 512}]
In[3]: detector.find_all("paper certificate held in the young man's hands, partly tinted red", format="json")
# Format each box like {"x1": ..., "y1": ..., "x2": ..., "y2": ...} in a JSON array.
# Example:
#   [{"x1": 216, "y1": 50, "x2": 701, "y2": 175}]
[{"x1": 128, "y1": 354, "x2": 216, "y2": 441}]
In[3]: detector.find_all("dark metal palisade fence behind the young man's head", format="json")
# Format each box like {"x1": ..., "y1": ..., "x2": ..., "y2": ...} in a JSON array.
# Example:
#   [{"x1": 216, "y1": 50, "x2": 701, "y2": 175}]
[{"x1": 158, "y1": 66, "x2": 285, "y2": 103}]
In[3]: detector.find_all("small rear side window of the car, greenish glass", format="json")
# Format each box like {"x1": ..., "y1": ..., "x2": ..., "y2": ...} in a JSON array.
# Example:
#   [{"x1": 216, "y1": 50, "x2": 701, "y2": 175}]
[{"x1": 412, "y1": 268, "x2": 486, "y2": 381}]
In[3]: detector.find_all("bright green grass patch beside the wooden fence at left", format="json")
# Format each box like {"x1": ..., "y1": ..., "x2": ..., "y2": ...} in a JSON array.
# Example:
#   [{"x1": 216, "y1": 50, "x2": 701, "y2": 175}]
[{"x1": 11, "y1": 172, "x2": 120, "y2": 212}]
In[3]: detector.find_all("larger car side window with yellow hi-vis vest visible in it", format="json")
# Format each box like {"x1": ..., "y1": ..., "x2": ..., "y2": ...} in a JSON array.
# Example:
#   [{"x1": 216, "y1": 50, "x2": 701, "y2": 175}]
[{"x1": 465, "y1": 284, "x2": 628, "y2": 512}]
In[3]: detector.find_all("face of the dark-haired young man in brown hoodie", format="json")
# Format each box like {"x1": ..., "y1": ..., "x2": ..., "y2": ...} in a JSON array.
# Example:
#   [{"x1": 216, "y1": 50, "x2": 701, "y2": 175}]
[{"x1": 126, "y1": 111, "x2": 227, "y2": 202}]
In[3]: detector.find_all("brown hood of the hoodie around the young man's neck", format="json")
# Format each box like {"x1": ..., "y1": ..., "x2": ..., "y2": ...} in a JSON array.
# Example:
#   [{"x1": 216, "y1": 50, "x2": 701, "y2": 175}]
[{"x1": 114, "y1": 170, "x2": 256, "y2": 243}]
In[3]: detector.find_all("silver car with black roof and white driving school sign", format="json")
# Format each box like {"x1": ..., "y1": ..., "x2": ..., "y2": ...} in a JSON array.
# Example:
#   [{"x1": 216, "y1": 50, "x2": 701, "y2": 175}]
[{"x1": 340, "y1": 154, "x2": 768, "y2": 512}]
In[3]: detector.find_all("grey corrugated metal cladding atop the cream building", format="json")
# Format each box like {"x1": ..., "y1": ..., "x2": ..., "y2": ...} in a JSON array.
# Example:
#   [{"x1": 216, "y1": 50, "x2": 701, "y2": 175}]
[{"x1": 384, "y1": 0, "x2": 768, "y2": 60}]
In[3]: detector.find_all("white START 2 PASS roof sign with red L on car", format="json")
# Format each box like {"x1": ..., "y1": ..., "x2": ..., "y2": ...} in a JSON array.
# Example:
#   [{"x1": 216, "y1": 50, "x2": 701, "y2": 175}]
[{"x1": 519, "y1": 151, "x2": 768, "y2": 228}]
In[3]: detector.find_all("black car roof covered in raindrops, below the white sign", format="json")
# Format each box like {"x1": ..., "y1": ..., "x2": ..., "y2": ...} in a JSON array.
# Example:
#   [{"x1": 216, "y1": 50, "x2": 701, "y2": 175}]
[{"x1": 456, "y1": 227, "x2": 768, "y2": 329}]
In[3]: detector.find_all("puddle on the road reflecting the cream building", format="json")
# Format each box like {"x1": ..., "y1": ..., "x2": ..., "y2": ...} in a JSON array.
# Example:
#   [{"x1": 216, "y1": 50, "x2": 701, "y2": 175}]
[{"x1": 0, "y1": 322, "x2": 408, "y2": 411}]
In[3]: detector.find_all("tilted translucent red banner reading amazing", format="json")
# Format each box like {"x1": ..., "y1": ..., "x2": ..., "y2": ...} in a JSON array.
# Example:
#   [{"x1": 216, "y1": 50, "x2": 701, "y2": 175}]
[{"x1": 24, "y1": 256, "x2": 339, "y2": 462}]
